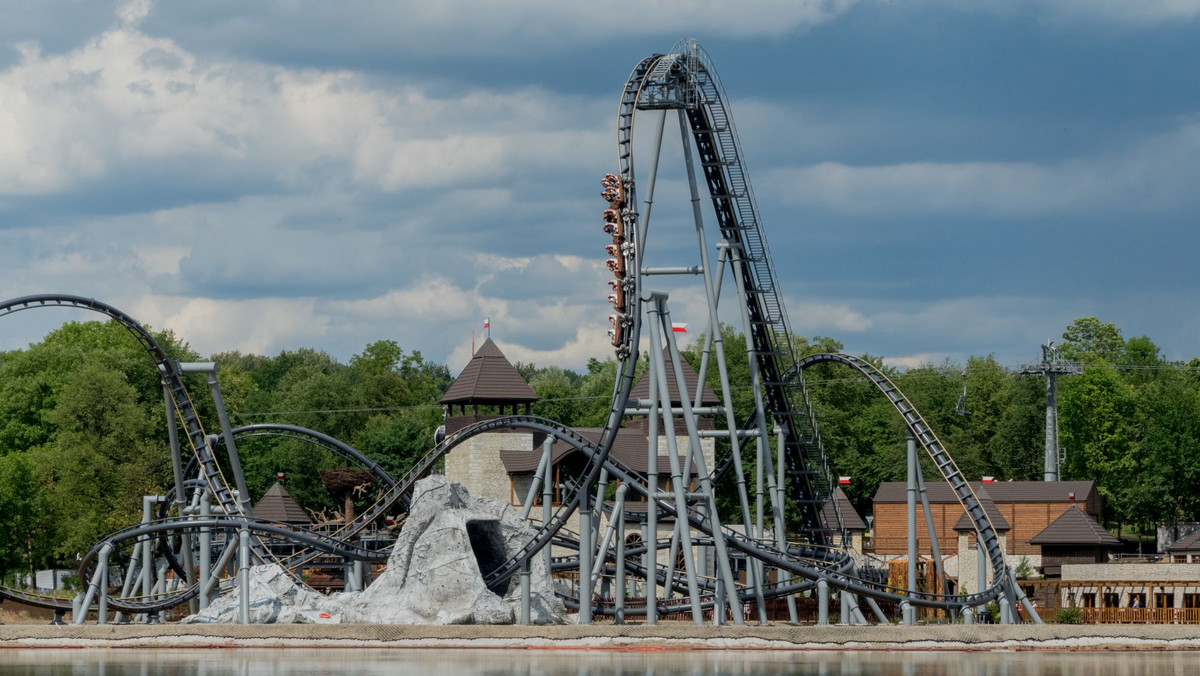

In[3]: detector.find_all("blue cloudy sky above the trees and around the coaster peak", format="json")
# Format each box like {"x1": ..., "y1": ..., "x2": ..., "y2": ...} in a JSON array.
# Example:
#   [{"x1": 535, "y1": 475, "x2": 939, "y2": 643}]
[{"x1": 0, "y1": 0, "x2": 1200, "y2": 372}]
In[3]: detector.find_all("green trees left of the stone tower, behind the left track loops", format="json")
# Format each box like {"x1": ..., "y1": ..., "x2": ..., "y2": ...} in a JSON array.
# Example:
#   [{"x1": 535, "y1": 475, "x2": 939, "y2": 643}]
[{"x1": 0, "y1": 322, "x2": 451, "y2": 575}]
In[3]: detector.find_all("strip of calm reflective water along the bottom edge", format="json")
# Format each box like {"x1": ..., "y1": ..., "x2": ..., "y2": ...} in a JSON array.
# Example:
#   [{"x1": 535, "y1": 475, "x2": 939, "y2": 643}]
[{"x1": 0, "y1": 648, "x2": 1200, "y2": 676}]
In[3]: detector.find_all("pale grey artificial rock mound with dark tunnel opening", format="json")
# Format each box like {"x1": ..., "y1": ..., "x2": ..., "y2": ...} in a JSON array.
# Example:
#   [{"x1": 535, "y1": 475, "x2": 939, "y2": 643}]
[{"x1": 184, "y1": 475, "x2": 566, "y2": 624}]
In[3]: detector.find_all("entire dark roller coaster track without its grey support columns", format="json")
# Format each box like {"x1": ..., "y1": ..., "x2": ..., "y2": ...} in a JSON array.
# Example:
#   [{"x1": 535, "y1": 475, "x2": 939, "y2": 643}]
[{"x1": 0, "y1": 41, "x2": 1022, "y2": 611}]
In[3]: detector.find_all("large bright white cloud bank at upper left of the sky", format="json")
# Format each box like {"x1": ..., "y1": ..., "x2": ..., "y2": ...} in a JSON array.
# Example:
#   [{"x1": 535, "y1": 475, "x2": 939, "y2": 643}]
[{"x1": 0, "y1": 20, "x2": 607, "y2": 204}]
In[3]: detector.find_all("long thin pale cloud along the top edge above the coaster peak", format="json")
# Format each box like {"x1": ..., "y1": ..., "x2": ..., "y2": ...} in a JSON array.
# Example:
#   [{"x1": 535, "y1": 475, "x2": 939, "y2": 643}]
[{"x1": 136, "y1": 0, "x2": 856, "y2": 70}]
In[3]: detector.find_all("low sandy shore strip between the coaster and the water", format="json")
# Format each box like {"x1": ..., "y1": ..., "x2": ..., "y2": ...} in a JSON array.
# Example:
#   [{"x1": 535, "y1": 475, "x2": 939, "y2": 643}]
[{"x1": 0, "y1": 623, "x2": 1200, "y2": 651}]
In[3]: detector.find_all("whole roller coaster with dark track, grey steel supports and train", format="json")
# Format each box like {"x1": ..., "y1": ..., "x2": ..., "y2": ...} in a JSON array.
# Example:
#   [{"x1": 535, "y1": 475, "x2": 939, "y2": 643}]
[{"x1": 0, "y1": 40, "x2": 1039, "y2": 623}]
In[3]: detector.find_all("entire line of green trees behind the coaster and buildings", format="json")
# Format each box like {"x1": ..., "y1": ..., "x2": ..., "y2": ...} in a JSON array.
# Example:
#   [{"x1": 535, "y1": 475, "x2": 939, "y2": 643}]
[{"x1": 0, "y1": 317, "x2": 1200, "y2": 579}]
